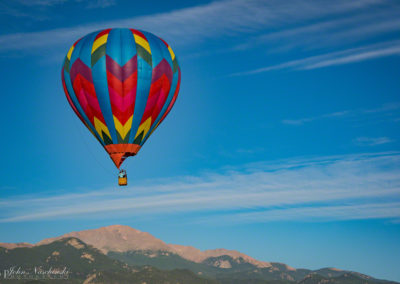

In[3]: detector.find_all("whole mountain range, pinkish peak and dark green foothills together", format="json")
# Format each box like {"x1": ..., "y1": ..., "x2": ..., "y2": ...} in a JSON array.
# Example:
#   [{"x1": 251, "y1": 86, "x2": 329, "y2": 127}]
[{"x1": 0, "y1": 225, "x2": 395, "y2": 284}]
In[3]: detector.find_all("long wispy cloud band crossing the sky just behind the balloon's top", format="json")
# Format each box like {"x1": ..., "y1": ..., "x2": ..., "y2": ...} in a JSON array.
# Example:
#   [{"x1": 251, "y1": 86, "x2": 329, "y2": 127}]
[{"x1": 0, "y1": 0, "x2": 388, "y2": 52}]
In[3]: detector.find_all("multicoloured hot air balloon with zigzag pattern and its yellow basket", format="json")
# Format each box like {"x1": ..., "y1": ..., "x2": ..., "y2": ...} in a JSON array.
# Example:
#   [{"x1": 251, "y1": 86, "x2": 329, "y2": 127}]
[{"x1": 61, "y1": 29, "x2": 181, "y2": 185}]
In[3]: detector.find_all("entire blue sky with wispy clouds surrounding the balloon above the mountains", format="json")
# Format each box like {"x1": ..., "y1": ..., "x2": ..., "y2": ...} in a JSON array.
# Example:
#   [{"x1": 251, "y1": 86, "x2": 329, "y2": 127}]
[{"x1": 0, "y1": 0, "x2": 400, "y2": 281}]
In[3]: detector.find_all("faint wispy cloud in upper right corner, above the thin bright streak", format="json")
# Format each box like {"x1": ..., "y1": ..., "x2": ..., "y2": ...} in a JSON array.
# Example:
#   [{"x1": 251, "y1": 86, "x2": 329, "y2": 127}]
[{"x1": 234, "y1": 6, "x2": 400, "y2": 51}]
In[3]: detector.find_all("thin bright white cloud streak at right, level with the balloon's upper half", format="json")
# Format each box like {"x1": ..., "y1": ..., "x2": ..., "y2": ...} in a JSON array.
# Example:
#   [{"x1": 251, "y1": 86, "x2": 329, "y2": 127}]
[{"x1": 230, "y1": 40, "x2": 400, "y2": 76}]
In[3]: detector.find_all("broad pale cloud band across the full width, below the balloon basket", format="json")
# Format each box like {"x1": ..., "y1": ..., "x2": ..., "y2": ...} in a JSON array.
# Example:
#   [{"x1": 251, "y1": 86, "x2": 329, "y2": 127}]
[{"x1": 0, "y1": 152, "x2": 400, "y2": 222}]
